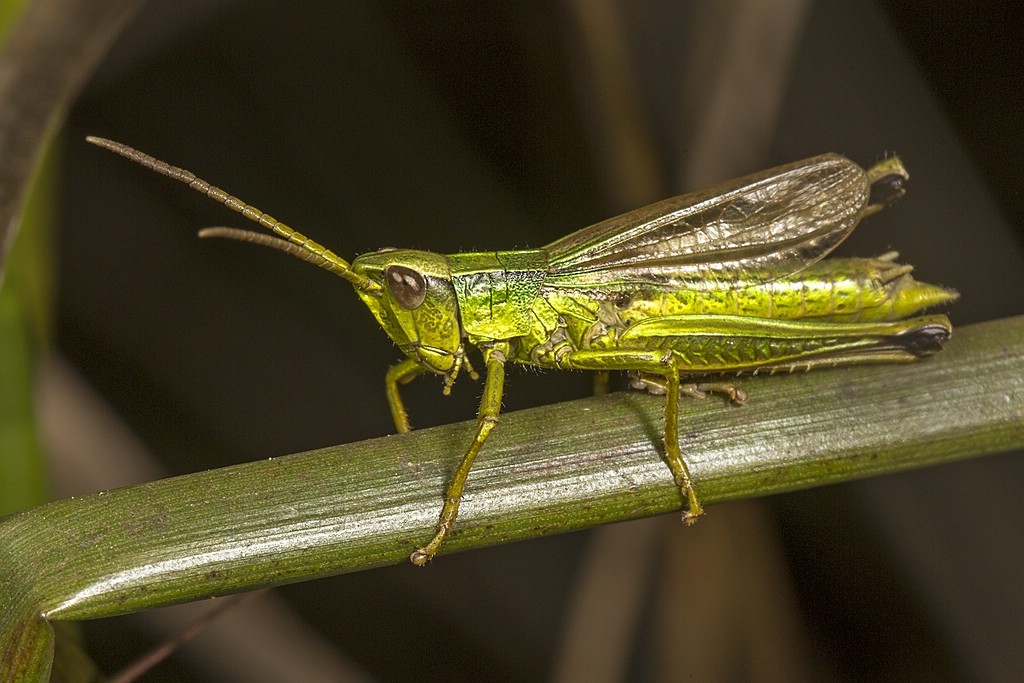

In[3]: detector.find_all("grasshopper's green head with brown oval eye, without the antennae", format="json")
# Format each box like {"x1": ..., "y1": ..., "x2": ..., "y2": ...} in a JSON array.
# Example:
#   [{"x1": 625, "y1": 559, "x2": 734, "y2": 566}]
[{"x1": 352, "y1": 250, "x2": 463, "y2": 379}]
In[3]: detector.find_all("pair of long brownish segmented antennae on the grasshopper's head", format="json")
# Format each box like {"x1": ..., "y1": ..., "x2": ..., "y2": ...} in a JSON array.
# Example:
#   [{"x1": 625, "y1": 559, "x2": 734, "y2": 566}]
[{"x1": 85, "y1": 135, "x2": 381, "y2": 293}]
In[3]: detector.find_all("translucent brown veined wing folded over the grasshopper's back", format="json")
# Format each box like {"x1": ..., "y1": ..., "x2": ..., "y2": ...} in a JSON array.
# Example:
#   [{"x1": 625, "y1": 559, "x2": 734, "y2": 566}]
[{"x1": 545, "y1": 154, "x2": 870, "y2": 291}]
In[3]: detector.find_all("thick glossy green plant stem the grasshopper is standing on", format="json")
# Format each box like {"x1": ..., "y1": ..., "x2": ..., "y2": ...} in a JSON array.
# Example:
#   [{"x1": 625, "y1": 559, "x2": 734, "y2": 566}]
[{"x1": 0, "y1": 316, "x2": 1024, "y2": 679}]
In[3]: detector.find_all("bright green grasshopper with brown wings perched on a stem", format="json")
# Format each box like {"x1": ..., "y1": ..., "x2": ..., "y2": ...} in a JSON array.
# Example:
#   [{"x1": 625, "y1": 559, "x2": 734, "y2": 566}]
[{"x1": 88, "y1": 137, "x2": 957, "y2": 566}]
